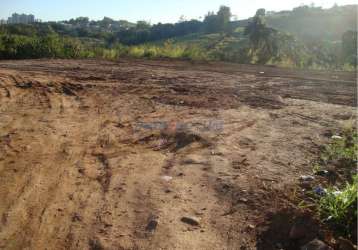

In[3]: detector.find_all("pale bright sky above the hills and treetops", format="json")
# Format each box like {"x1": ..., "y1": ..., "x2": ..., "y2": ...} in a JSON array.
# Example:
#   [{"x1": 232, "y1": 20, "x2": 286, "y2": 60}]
[{"x1": 0, "y1": 0, "x2": 356, "y2": 24}]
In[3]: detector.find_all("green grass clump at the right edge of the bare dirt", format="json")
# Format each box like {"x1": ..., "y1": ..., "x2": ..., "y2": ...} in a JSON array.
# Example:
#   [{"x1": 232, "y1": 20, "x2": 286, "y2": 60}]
[{"x1": 313, "y1": 126, "x2": 358, "y2": 239}]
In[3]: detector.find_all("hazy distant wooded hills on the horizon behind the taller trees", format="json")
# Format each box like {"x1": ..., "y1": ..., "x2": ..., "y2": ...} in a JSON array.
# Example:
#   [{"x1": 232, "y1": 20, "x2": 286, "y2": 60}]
[{"x1": 0, "y1": 5, "x2": 358, "y2": 45}]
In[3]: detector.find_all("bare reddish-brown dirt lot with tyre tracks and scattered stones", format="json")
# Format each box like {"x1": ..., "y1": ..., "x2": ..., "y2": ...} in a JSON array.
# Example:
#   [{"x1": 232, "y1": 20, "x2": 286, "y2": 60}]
[{"x1": 0, "y1": 60, "x2": 357, "y2": 250}]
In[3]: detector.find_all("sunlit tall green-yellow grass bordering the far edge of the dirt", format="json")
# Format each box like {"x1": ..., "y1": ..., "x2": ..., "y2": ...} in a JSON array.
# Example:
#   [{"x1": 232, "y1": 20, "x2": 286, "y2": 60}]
[{"x1": 0, "y1": 33, "x2": 357, "y2": 70}]
